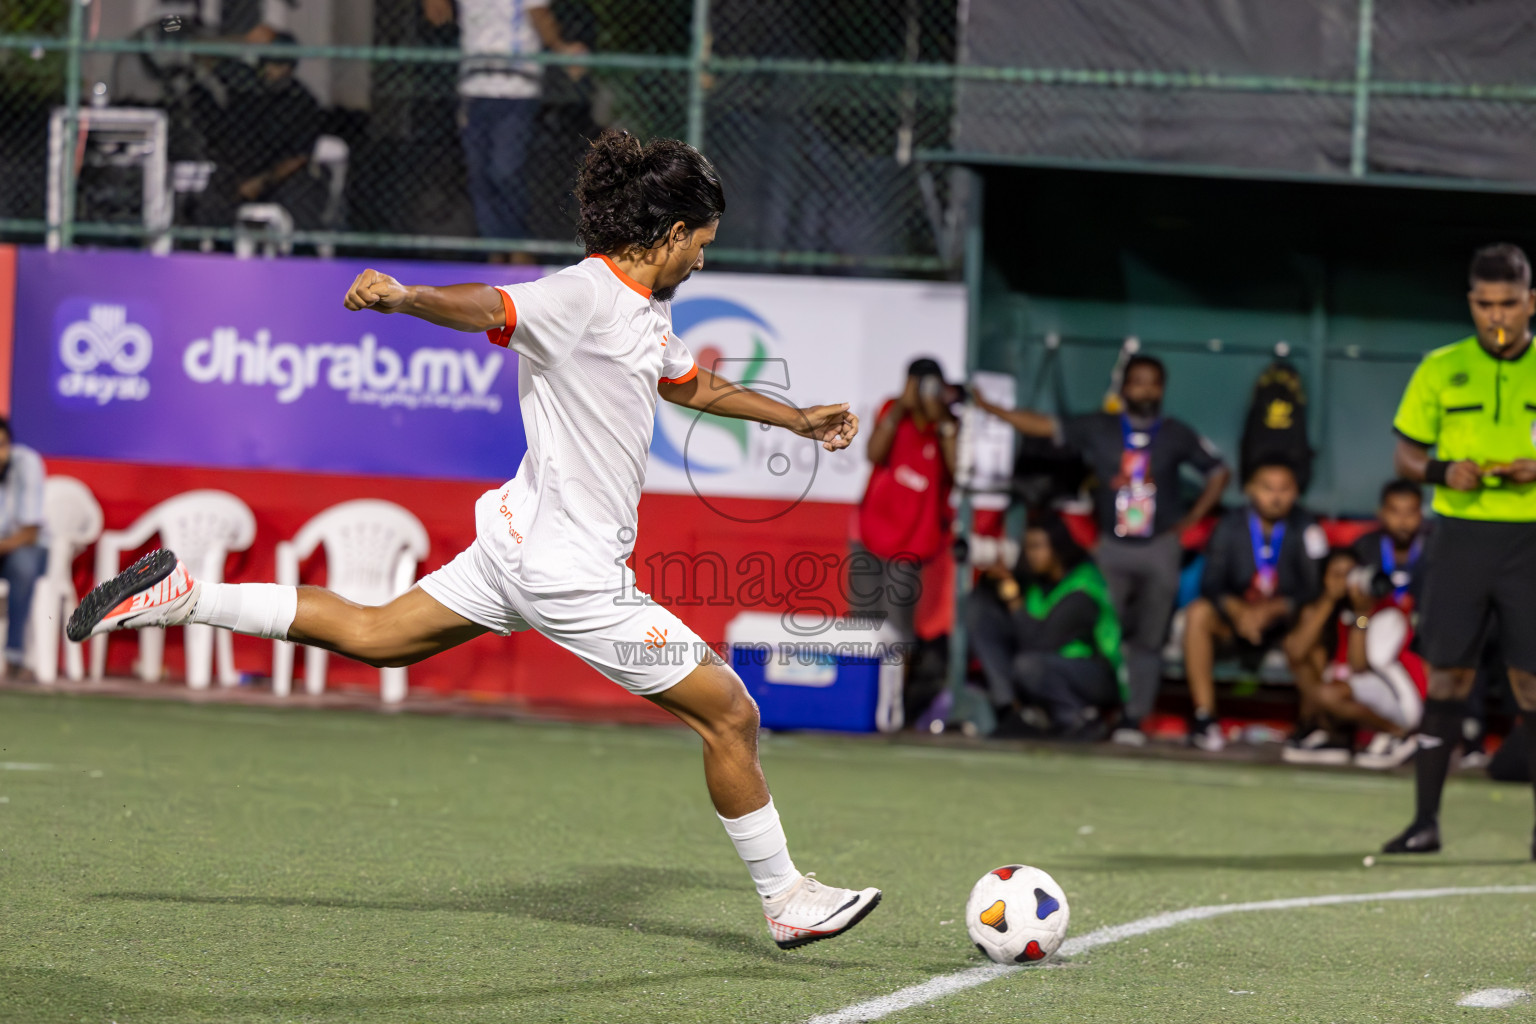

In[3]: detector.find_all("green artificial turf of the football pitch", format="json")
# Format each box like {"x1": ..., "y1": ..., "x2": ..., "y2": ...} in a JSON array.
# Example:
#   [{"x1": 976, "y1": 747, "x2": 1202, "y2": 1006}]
[{"x1": 0, "y1": 694, "x2": 1536, "y2": 1024}]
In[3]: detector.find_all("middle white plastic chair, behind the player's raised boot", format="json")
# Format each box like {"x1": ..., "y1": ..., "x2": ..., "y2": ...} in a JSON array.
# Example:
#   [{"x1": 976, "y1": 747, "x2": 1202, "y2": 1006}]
[{"x1": 91, "y1": 491, "x2": 257, "y2": 689}]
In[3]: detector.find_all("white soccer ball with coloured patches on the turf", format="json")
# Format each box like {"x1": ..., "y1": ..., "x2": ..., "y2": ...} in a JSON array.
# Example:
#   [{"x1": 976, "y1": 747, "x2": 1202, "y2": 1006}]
[{"x1": 965, "y1": 864, "x2": 1071, "y2": 964}]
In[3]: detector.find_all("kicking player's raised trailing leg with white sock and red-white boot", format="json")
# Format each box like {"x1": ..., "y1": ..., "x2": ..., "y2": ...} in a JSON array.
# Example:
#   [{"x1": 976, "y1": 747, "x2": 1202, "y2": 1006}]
[{"x1": 68, "y1": 550, "x2": 487, "y2": 668}]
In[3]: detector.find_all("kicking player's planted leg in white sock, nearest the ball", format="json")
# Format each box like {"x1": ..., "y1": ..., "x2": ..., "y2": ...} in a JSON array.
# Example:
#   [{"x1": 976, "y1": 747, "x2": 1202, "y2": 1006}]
[{"x1": 651, "y1": 662, "x2": 880, "y2": 949}]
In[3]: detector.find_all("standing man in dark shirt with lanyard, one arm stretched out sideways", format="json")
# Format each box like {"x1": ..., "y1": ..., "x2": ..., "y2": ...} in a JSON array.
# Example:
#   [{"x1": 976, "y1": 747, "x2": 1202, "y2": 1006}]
[{"x1": 975, "y1": 355, "x2": 1232, "y2": 743}]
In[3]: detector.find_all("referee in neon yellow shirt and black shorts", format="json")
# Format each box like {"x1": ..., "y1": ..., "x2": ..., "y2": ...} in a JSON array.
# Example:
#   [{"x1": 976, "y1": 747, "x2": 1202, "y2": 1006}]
[{"x1": 1384, "y1": 246, "x2": 1536, "y2": 858}]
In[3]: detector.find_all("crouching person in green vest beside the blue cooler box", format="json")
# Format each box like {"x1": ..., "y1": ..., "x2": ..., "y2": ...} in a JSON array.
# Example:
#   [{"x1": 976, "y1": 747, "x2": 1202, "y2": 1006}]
[{"x1": 966, "y1": 513, "x2": 1123, "y2": 738}]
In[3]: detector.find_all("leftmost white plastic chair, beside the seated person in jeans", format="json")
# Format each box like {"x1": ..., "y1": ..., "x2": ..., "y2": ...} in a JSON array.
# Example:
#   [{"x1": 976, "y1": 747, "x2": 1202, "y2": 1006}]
[{"x1": 26, "y1": 476, "x2": 101, "y2": 683}]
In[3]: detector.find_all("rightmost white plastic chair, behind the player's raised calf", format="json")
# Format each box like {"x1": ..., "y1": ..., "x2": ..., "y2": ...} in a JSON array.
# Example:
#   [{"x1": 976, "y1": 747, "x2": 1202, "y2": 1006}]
[{"x1": 272, "y1": 499, "x2": 429, "y2": 703}]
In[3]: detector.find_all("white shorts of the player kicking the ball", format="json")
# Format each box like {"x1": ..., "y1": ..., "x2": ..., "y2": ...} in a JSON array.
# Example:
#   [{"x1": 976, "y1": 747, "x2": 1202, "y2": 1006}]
[{"x1": 419, "y1": 539, "x2": 711, "y2": 697}]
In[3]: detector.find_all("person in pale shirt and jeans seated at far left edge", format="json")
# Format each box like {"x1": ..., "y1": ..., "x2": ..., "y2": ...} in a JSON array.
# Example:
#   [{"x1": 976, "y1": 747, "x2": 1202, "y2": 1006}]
[{"x1": 0, "y1": 416, "x2": 48, "y2": 672}]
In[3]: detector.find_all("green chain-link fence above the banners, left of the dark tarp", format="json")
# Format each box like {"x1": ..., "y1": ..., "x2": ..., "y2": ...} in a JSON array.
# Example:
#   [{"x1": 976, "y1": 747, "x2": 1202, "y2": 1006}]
[{"x1": 0, "y1": 0, "x2": 955, "y2": 275}]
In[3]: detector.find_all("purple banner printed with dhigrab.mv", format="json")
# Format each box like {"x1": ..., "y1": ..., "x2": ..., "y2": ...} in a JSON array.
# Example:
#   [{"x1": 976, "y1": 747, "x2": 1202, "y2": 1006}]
[{"x1": 12, "y1": 249, "x2": 542, "y2": 481}]
